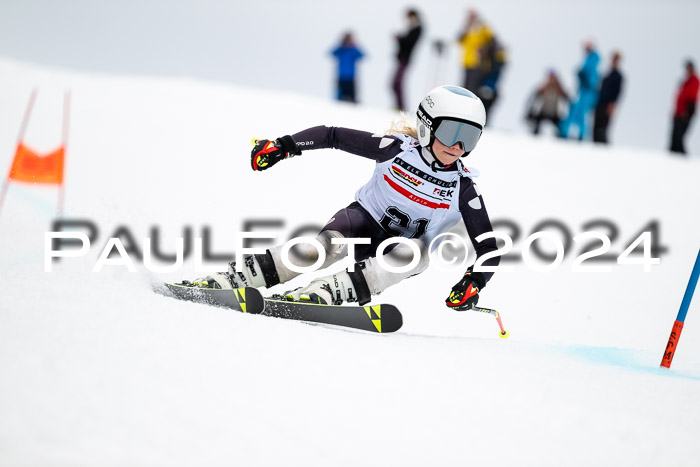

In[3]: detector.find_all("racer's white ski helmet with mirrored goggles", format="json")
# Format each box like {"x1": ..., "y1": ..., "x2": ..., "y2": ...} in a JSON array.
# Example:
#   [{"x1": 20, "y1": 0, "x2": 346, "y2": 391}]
[{"x1": 417, "y1": 86, "x2": 486, "y2": 156}]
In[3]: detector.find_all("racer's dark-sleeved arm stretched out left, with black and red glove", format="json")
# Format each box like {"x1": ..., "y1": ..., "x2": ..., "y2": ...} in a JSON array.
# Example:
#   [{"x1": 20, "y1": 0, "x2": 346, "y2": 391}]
[{"x1": 250, "y1": 126, "x2": 401, "y2": 170}]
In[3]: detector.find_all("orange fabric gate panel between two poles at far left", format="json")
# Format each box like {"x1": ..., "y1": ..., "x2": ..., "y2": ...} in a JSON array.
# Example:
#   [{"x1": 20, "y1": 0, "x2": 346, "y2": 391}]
[{"x1": 8, "y1": 143, "x2": 65, "y2": 185}]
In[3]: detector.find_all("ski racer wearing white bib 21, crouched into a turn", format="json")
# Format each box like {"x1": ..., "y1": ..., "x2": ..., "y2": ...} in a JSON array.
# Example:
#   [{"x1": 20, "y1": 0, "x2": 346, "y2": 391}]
[{"x1": 195, "y1": 86, "x2": 499, "y2": 310}]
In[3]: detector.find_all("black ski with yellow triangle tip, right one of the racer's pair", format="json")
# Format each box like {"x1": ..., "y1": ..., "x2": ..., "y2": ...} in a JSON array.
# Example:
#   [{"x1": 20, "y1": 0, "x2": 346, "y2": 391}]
[{"x1": 263, "y1": 298, "x2": 403, "y2": 334}]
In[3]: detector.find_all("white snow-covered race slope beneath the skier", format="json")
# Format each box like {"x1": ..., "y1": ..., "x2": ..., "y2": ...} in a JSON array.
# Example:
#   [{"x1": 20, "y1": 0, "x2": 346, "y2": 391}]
[{"x1": 0, "y1": 59, "x2": 700, "y2": 466}]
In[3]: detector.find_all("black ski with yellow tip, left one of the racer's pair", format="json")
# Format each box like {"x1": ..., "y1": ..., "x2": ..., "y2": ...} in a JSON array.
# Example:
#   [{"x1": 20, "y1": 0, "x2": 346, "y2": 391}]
[{"x1": 165, "y1": 282, "x2": 265, "y2": 314}]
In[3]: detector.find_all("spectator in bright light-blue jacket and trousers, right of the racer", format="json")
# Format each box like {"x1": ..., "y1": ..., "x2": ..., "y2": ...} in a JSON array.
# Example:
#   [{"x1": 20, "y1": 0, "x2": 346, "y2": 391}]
[{"x1": 559, "y1": 41, "x2": 600, "y2": 140}]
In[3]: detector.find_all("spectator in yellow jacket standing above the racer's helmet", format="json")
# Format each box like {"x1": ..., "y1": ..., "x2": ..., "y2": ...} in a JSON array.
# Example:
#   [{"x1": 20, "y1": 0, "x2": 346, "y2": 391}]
[{"x1": 458, "y1": 10, "x2": 493, "y2": 95}]
